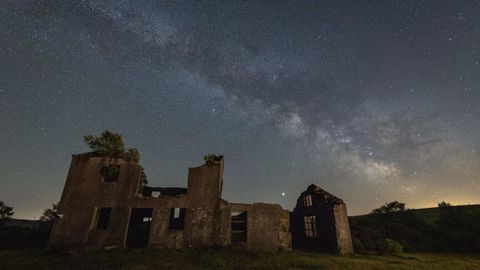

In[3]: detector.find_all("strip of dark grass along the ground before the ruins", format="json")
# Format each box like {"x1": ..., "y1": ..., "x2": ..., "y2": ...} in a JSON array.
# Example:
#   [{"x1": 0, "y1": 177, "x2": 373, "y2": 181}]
[{"x1": 0, "y1": 249, "x2": 480, "y2": 270}]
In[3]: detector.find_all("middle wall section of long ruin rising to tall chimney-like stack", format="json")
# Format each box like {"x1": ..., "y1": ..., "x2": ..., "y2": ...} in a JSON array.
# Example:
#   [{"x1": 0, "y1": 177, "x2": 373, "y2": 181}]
[{"x1": 133, "y1": 160, "x2": 223, "y2": 249}]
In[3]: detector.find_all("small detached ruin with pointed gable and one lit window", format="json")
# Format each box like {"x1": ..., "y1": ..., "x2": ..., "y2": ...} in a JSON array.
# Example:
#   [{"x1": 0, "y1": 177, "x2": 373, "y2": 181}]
[{"x1": 291, "y1": 185, "x2": 353, "y2": 254}]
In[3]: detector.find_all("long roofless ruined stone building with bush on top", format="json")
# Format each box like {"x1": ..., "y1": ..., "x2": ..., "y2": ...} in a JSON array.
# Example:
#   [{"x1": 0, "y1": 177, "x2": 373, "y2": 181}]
[{"x1": 49, "y1": 154, "x2": 291, "y2": 250}]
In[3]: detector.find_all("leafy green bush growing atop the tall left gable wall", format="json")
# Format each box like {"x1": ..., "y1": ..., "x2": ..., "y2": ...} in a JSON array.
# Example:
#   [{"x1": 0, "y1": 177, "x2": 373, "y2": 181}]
[{"x1": 83, "y1": 130, "x2": 140, "y2": 162}]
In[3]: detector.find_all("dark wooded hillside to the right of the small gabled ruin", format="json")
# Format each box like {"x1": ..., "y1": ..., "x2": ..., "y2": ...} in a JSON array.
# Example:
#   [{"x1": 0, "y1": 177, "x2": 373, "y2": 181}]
[{"x1": 349, "y1": 205, "x2": 480, "y2": 252}]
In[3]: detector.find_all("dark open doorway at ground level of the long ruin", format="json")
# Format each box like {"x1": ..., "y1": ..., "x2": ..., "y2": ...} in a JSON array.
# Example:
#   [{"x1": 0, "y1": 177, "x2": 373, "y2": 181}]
[{"x1": 126, "y1": 208, "x2": 153, "y2": 247}]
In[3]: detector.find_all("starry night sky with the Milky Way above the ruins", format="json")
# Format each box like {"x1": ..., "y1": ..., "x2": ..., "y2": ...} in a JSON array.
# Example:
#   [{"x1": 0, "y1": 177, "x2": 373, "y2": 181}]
[{"x1": 0, "y1": 0, "x2": 480, "y2": 219}]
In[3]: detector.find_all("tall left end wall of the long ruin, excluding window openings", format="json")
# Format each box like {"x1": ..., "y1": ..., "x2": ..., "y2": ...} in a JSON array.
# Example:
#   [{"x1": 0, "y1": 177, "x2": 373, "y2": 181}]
[{"x1": 49, "y1": 155, "x2": 141, "y2": 248}]
